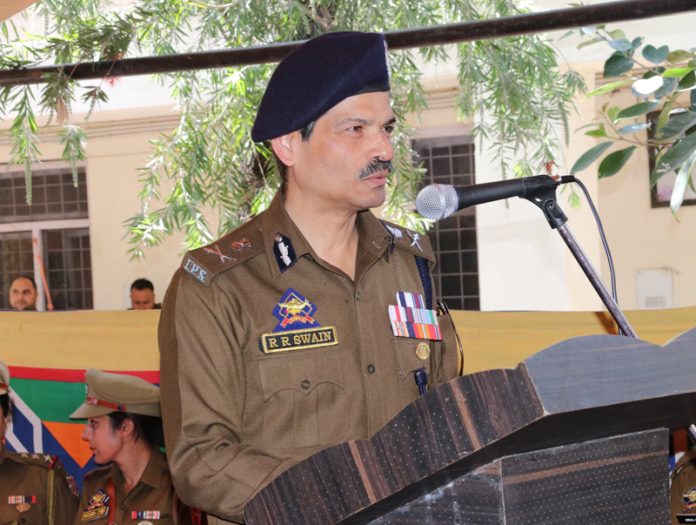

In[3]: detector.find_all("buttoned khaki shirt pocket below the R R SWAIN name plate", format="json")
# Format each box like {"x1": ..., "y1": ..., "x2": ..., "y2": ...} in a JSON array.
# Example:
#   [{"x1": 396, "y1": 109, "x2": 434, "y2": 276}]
[{"x1": 258, "y1": 349, "x2": 350, "y2": 448}]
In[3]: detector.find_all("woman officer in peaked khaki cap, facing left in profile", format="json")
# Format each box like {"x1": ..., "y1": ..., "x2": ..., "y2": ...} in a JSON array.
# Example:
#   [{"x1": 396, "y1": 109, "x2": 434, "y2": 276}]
[{"x1": 70, "y1": 369, "x2": 204, "y2": 525}]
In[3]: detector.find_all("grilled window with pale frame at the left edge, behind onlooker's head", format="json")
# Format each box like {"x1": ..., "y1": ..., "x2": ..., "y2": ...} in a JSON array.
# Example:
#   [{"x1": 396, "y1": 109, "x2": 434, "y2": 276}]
[{"x1": 0, "y1": 163, "x2": 93, "y2": 310}]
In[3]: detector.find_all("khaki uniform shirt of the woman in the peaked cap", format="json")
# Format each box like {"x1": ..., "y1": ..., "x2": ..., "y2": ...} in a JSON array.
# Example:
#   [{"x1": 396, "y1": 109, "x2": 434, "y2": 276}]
[{"x1": 74, "y1": 450, "x2": 201, "y2": 525}]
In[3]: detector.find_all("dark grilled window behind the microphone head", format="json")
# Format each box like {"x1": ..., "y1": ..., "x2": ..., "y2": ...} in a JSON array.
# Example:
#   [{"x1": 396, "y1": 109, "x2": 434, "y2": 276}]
[{"x1": 413, "y1": 136, "x2": 480, "y2": 310}]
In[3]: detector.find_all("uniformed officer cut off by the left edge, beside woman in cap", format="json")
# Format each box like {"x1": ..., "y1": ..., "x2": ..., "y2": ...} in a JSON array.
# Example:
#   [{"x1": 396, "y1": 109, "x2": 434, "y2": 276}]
[{"x1": 0, "y1": 362, "x2": 77, "y2": 525}]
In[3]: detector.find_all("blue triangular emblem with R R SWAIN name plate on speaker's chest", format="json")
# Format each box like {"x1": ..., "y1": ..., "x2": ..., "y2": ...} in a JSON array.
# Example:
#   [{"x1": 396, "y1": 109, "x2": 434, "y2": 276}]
[{"x1": 259, "y1": 288, "x2": 338, "y2": 354}]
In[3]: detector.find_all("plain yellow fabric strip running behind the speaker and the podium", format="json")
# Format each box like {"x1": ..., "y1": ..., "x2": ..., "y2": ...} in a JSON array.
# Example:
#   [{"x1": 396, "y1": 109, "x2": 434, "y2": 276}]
[{"x1": 0, "y1": 307, "x2": 696, "y2": 373}]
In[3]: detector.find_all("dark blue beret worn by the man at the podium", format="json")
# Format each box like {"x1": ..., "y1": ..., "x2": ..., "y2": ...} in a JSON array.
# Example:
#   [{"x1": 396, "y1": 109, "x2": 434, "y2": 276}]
[{"x1": 251, "y1": 32, "x2": 389, "y2": 142}]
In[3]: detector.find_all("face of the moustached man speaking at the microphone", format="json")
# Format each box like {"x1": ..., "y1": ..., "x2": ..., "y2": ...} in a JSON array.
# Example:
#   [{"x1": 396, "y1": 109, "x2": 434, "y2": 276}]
[{"x1": 288, "y1": 91, "x2": 395, "y2": 213}]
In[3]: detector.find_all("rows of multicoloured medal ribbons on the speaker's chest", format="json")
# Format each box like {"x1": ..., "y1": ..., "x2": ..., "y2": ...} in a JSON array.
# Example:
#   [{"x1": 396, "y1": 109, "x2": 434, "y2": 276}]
[{"x1": 389, "y1": 292, "x2": 442, "y2": 341}]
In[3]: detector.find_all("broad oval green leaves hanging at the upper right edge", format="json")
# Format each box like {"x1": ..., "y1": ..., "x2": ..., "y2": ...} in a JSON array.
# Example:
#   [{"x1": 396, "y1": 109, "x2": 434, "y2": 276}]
[{"x1": 571, "y1": 26, "x2": 696, "y2": 213}]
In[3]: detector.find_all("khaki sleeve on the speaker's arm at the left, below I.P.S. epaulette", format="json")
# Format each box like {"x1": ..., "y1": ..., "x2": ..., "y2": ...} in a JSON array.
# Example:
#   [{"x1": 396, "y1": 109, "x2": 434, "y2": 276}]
[{"x1": 159, "y1": 270, "x2": 290, "y2": 523}]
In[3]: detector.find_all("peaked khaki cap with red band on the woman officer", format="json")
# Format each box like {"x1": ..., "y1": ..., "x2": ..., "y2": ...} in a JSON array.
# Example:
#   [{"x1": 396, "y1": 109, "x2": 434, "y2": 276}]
[{"x1": 70, "y1": 368, "x2": 162, "y2": 419}]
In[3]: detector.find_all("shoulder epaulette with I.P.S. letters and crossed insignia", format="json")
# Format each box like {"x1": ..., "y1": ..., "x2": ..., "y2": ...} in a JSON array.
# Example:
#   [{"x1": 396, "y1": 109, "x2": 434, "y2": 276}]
[{"x1": 181, "y1": 220, "x2": 264, "y2": 286}]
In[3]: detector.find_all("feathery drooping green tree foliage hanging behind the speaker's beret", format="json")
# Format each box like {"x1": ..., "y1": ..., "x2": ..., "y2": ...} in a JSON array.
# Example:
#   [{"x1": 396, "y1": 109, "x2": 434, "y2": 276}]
[{"x1": 0, "y1": 0, "x2": 581, "y2": 257}]
